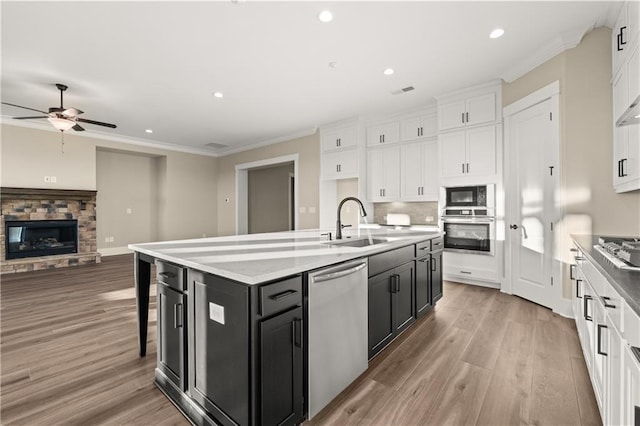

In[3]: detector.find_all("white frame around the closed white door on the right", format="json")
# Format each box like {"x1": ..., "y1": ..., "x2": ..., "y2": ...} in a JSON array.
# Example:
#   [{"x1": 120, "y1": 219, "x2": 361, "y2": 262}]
[{"x1": 502, "y1": 80, "x2": 571, "y2": 316}]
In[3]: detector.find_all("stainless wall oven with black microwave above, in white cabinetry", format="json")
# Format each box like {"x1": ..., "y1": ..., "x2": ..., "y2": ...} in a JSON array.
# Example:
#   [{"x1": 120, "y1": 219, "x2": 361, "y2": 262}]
[{"x1": 442, "y1": 185, "x2": 496, "y2": 256}]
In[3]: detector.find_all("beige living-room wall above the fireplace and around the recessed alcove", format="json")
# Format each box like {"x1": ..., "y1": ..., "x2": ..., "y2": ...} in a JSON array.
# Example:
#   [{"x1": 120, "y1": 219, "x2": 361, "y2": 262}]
[{"x1": 0, "y1": 124, "x2": 218, "y2": 246}]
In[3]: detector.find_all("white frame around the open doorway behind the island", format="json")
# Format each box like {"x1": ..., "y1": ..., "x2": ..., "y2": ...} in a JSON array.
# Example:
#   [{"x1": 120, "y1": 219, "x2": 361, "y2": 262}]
[{"x1": 235, "y1": 154, "x2": 300, "y2": 235}]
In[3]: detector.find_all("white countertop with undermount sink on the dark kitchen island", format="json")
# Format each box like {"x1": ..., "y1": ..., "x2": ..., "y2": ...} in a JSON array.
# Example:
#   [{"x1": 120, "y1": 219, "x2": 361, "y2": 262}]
[{"x1": 129, "y1": 229, "x2": 442, "y2": 285}]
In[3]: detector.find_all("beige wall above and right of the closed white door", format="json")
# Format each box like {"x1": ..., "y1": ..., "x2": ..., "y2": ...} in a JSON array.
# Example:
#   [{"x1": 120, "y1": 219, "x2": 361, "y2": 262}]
[{"x1": 502, "y1": 27, "x2": 640, "y2": 297}]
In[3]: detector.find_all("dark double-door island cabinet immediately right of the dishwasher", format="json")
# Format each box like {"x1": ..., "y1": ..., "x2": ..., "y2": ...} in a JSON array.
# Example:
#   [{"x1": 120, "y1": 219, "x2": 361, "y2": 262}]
[{"x1": 368, "y1": 245, "x2": 415, "y2": 359}]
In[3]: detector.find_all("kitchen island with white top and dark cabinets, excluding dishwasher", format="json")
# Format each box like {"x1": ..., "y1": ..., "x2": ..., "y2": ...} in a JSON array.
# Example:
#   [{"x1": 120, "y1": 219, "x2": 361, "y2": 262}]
[{"x1": 129, "y1": 228, "x2": 442, "y2": 425}]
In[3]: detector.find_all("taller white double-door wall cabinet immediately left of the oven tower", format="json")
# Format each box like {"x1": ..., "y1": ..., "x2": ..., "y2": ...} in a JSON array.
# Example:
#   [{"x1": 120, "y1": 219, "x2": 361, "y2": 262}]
[{"x1": 400, "y1": 139, "x2": 438, "y2": 201}]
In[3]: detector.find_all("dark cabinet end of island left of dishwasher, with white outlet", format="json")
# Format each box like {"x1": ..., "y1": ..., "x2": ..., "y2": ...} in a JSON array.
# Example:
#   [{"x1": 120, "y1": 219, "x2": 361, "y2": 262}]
[{"x1": 155, "y1": 268, "x2": 305, "y2": 426}]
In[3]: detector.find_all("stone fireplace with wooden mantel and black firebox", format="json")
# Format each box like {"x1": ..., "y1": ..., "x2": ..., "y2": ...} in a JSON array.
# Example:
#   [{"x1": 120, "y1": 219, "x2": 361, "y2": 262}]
[{"x1": 0, "y1": 188, "x2": 100, "y2": 274}]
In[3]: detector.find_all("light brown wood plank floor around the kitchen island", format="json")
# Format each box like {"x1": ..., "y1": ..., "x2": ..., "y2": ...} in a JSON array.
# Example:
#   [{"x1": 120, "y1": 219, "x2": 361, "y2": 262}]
[{"x1": 0, "y1": 255, "x2": 600, "y2": 426}]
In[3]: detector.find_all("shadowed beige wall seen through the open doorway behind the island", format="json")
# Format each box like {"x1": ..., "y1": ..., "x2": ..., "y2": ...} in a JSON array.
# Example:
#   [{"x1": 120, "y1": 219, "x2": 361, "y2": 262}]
[{"x1": 248, "y1": 163, "x2": 293, "y2": 234}]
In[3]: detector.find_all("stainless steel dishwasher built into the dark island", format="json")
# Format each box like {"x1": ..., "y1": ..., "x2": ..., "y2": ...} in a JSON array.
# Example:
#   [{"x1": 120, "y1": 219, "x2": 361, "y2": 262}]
[{"x1": 308, "y1": 259, "x2": 369, "y2": 419}]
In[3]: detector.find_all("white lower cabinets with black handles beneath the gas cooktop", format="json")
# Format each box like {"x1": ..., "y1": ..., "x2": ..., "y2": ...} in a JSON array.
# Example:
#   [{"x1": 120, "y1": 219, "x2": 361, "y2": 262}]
[{"x1": 571, "y1": 245, "x2": 640, "y2": 426}]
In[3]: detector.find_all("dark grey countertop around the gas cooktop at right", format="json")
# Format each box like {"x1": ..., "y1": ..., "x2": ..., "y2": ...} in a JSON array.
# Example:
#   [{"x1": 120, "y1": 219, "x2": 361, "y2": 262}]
[{"x1": 571, "y1": 235, "x2": 640, "y2": 316}]
